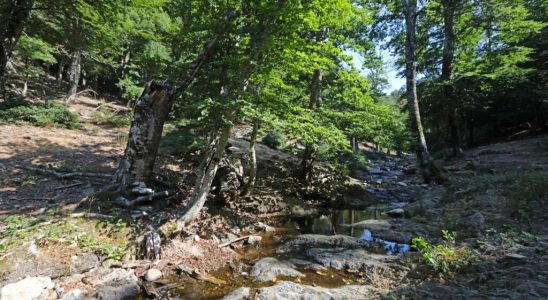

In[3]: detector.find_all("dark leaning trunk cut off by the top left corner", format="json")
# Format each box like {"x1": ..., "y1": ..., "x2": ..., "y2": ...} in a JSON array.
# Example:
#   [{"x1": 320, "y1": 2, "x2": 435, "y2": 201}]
[{"x1": 0, "y1": 0, "x2": 34, "y2": 81}]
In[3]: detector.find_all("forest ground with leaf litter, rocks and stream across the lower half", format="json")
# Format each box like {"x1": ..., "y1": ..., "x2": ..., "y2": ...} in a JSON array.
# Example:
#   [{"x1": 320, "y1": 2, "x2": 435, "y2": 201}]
[{"x1": 0, "y1": 92, "x2": 548, "y2": 299}]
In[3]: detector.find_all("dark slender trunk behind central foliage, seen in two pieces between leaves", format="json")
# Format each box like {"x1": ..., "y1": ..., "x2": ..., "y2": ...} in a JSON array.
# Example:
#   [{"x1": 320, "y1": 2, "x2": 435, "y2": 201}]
[{"x1": 301, "y1": 69, "x2": 323, "y2": 182}]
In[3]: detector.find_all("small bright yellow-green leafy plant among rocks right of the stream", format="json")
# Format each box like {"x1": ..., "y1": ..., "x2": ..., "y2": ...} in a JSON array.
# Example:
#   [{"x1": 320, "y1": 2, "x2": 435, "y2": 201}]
[{"x1": 411, "y1": 230, "x2": 477, "y2": 275}]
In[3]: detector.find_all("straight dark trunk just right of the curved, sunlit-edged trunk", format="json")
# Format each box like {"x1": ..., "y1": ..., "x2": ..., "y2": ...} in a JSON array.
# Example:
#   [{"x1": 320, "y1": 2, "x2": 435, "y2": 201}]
[{"x1": 441, "y1": 0, "x2": 462, "y2": 157}]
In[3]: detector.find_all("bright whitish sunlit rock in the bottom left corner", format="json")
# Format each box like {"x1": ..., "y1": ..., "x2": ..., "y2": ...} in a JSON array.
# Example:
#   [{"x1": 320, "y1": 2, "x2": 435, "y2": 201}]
[{"x1": 0, "y1": 277, "x2": 55, "y2": 300}]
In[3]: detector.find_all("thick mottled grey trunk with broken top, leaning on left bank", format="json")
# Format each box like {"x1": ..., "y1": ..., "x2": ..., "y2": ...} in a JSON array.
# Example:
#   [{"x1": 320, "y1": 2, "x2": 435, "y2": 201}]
[{"x1": 114, "y1": 82, "x2": 175, "y2": 196}]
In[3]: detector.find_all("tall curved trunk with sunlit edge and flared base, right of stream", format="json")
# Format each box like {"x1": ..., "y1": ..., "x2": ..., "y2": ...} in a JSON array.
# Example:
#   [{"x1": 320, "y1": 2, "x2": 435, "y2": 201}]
[{"x1": 402, "y1": 0, "x2": 443, "y2": 182}]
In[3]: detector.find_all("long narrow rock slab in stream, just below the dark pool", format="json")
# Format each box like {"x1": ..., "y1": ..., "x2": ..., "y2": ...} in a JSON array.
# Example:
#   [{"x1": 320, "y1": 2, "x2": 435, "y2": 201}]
[{"x1": 276, "y1": 234, "x2": 371, "y2": 253}]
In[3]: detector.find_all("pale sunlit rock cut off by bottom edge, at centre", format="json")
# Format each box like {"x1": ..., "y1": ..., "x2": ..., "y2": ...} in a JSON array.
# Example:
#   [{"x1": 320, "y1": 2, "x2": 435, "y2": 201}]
[{"x1": 255, "y1": 281, "x2": 378, "y2": 300}]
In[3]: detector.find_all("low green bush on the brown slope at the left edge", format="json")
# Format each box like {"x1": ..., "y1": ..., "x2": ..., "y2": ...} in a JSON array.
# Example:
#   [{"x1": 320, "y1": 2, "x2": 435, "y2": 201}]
[{"x1": 0, "y1": 101, "x2": 80, "y2": 129}]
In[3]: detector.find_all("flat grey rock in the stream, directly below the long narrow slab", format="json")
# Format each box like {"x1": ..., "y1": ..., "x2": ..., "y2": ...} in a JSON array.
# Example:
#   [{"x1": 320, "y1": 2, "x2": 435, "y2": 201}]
[{"x1": 306, "y1": 248, "x2": 394, "y2": 271}]
